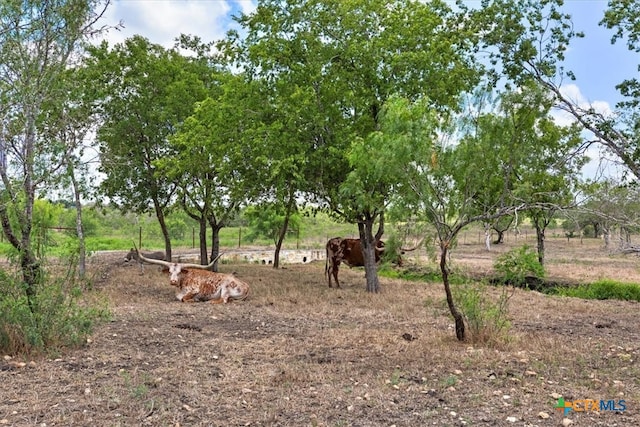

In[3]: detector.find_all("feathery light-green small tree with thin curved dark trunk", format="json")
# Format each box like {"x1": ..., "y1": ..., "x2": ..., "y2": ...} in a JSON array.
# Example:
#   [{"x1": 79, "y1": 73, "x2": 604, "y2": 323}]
[{"x1": 382, "y1": 93, "x2": 572, "y2": 340}]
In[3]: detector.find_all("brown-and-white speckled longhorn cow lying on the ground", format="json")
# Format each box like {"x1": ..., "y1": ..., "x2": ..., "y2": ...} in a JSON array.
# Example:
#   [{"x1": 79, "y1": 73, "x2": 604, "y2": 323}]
[{"x1": 138, "y1": 252, "x2": 249, "y2": 304}]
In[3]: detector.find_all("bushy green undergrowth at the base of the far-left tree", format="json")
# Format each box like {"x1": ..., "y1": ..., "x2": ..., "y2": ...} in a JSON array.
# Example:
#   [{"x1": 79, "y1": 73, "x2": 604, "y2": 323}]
[{"x1": 0, "y1": 270, "x2": 109, "y2": 355}]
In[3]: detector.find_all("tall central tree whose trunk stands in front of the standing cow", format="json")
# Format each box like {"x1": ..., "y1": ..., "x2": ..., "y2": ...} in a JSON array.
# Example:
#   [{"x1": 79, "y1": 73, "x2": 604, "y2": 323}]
[{"x1": 236, "y1": 0, "x2": 478, "y2": 292}]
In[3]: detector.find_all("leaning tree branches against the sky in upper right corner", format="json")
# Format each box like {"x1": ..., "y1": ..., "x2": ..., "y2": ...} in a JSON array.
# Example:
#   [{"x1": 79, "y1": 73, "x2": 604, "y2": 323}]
[{"x1": 478, "y1": 0, "x2": 640, "y2": 184}]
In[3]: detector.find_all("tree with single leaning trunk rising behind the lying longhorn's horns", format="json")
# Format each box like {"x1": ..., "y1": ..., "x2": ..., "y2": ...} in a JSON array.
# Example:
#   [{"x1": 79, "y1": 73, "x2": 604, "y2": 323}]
[{"x1": 87, "y1": 36, "x2": 207, "y2": 257}]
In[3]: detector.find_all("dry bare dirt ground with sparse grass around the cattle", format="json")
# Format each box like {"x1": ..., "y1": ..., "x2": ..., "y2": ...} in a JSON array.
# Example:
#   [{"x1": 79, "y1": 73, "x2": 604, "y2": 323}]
[{"x1": 0, "y1": 236, "x2": 640, "y2": 427}]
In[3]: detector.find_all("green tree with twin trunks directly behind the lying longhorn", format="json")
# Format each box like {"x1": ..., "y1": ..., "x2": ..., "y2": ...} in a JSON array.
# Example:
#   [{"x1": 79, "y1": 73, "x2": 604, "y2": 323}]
[{"x1": 168, "y1": 73, "x2": 266, "y2": 268}]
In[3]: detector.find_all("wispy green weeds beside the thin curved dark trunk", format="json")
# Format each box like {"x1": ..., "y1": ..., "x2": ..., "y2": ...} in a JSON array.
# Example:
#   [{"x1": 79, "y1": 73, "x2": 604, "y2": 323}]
[{"x1": 452, "y1": 282, "x2": 513, "y2": 346}]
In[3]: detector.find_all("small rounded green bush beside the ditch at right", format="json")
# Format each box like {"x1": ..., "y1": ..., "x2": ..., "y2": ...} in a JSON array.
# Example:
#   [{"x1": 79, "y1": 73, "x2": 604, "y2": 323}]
[{"x1": 494, "y1": 245, "x2": 544, "y2": 286}]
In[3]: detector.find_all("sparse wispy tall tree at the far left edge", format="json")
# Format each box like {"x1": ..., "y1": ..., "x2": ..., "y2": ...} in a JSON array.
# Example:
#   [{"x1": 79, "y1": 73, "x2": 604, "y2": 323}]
[{"x1": 0, "y1": 0, "x2": 108, "y2": 301}]
